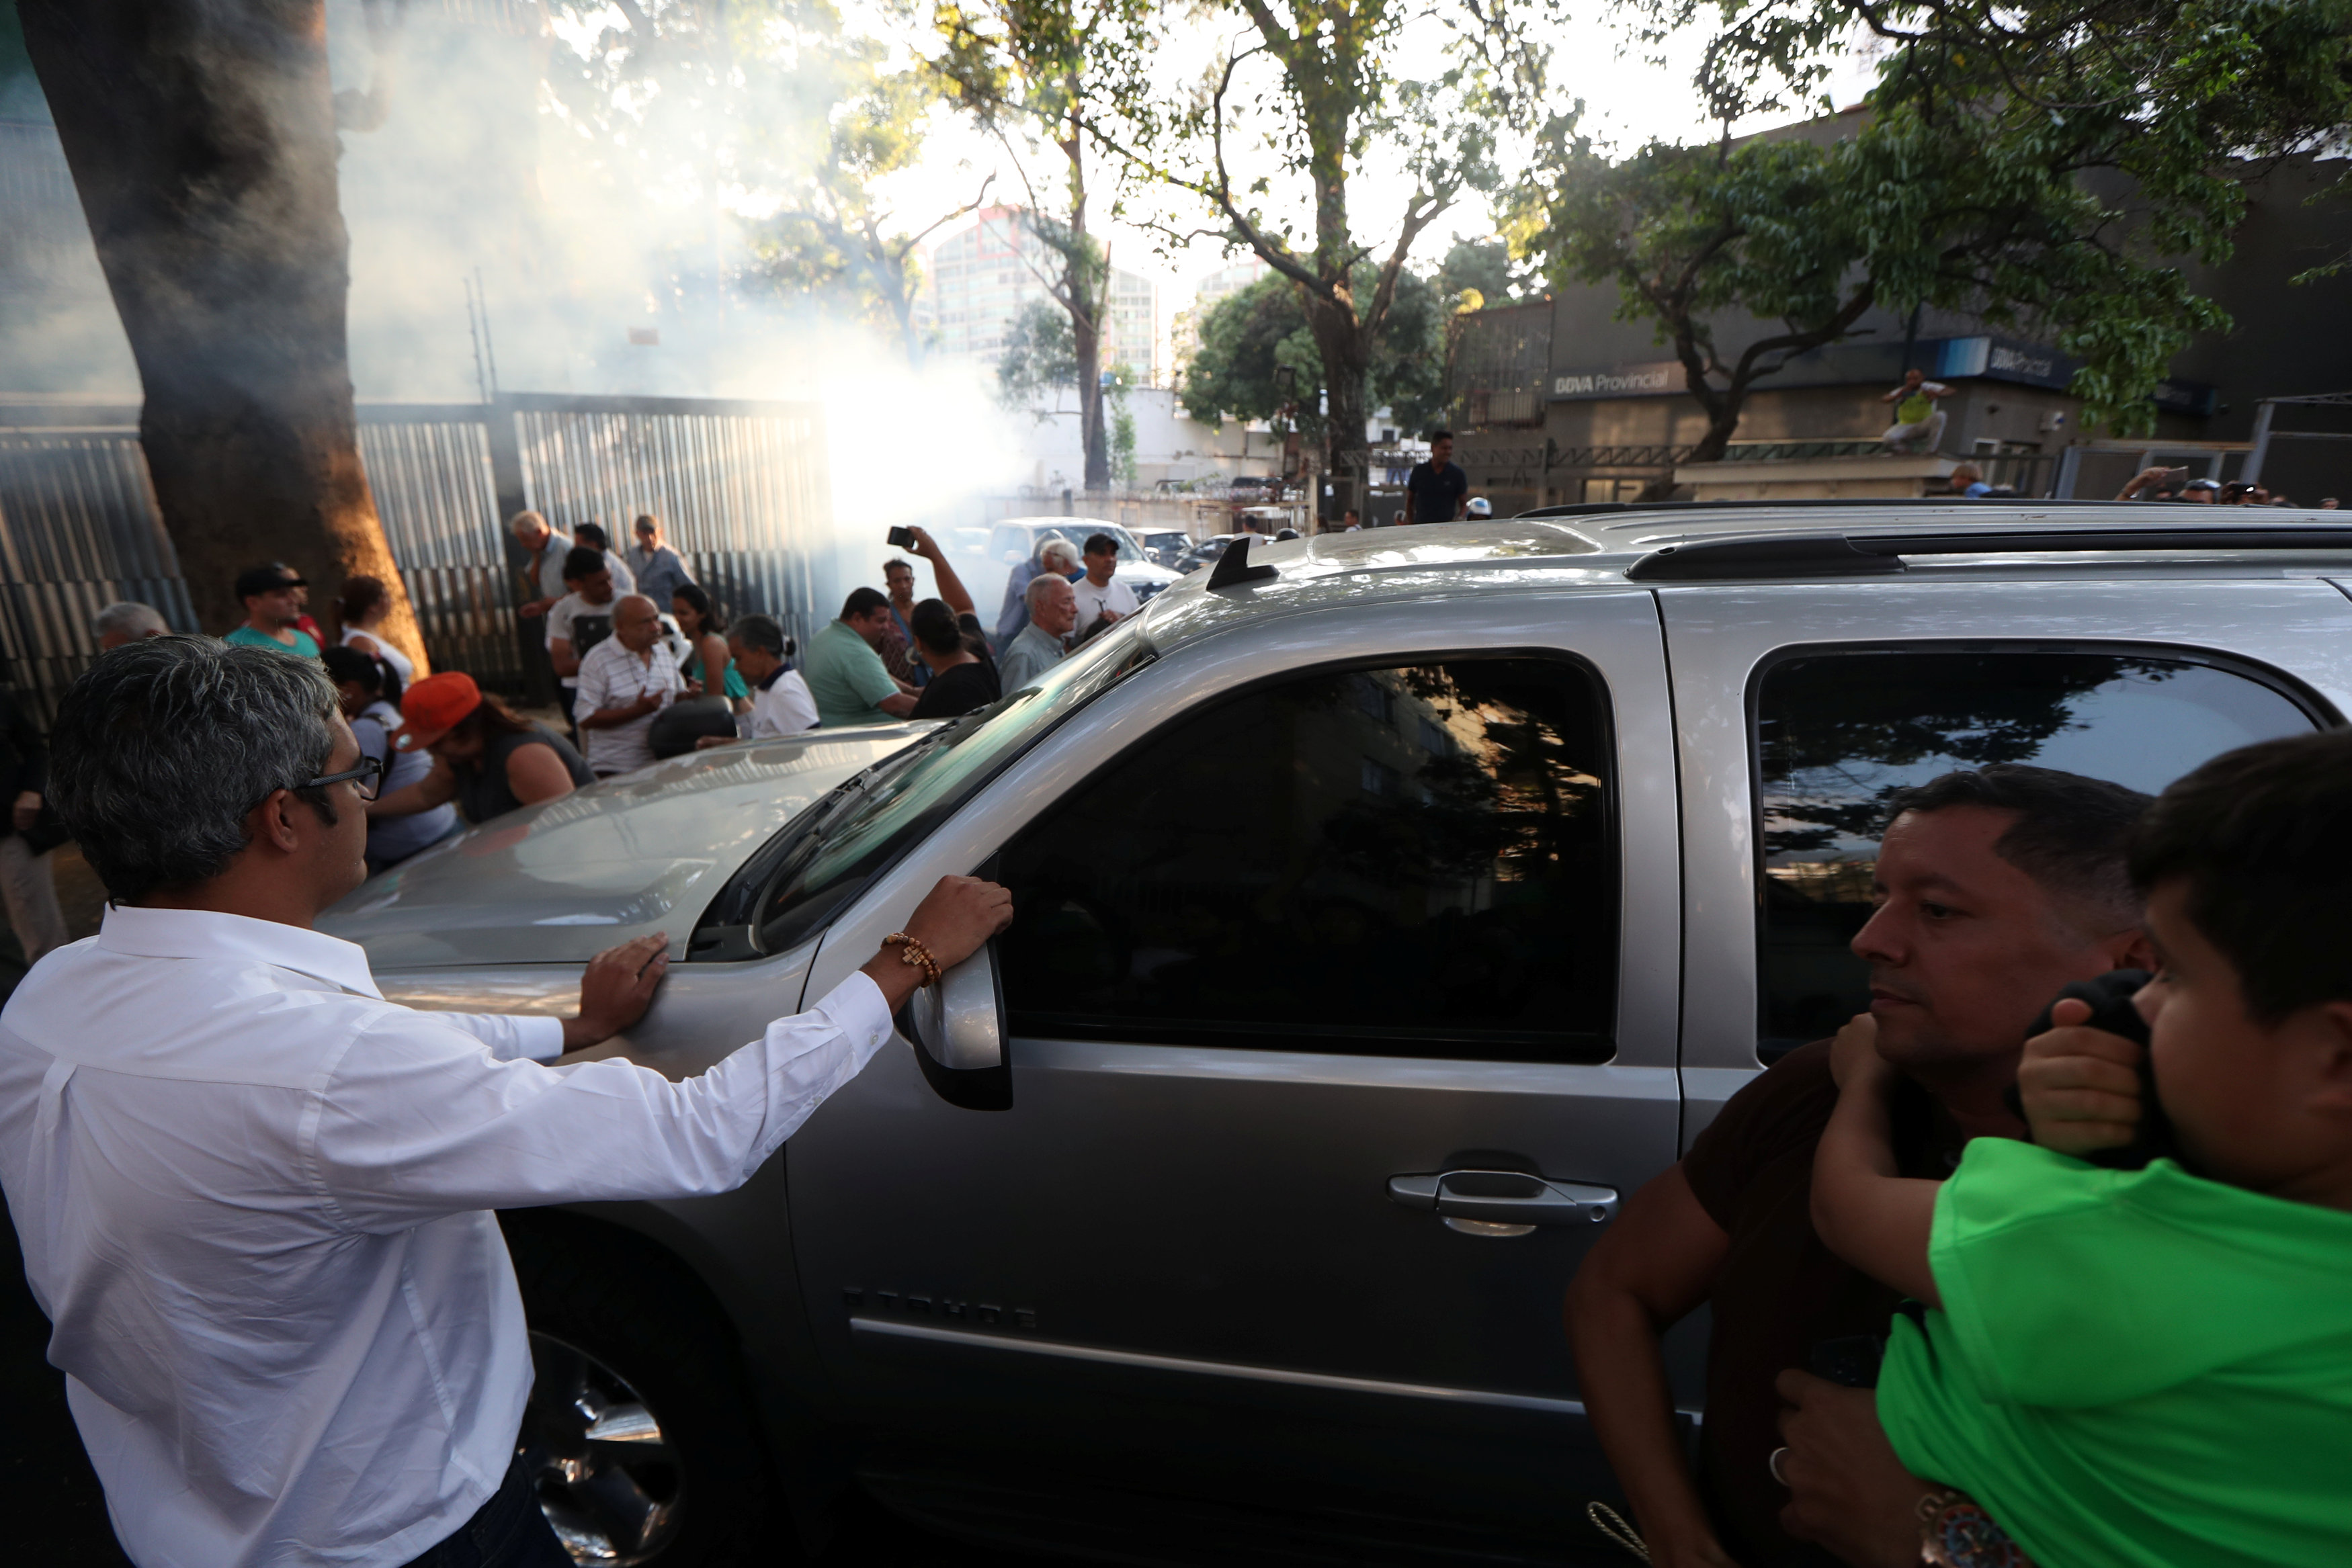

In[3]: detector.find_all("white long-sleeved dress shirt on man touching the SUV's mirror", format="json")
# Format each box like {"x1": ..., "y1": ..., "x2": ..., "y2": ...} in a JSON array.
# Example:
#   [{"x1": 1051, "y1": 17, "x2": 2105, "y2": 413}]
[{"x1": 0, "y1": 908, "x2": 892, "y2": 1568}]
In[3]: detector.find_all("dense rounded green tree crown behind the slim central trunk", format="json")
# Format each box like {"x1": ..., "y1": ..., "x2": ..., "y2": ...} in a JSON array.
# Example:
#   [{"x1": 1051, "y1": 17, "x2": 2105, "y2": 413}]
[{"x1": 1183, "y1": 263, "x2": 1447, "y2": 439}]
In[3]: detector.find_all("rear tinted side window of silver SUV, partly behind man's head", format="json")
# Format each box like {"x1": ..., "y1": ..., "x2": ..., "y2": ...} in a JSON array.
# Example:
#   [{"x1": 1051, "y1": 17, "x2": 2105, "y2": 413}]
[{"x1": 1757, "y1": 651, "x2": 2312, "y2": 1060}]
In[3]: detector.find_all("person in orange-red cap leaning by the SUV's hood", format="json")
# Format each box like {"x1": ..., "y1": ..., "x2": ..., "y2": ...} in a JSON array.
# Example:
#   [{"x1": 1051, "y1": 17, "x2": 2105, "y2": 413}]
[{"x1": 367, "y1": 670, "x2": 595, "y2": 823}]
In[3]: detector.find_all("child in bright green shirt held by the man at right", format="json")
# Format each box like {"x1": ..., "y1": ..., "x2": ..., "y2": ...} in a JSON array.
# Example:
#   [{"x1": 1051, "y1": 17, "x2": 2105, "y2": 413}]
[{"x1": 1814, "y1": 731, "x2": 2352, "y2": 1568}]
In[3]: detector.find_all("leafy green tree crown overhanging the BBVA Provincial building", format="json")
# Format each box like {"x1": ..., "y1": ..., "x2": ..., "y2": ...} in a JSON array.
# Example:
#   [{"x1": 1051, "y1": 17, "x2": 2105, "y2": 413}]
[{"x1": 1543, "y1": 0, "x2": 2352, "y2": 433}]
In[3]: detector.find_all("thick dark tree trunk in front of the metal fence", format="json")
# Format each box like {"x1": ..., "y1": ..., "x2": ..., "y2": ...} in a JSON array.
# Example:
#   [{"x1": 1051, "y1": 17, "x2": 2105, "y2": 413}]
[{"x1": 17, "y1": 0, "x2": 426, "y2": 670}]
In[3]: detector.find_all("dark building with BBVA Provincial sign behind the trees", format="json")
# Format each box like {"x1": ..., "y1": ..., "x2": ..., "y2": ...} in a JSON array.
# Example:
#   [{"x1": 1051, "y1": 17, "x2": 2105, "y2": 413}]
[{"x1": 1449, "y1": 162, "x2": 2352, "y2": 515}]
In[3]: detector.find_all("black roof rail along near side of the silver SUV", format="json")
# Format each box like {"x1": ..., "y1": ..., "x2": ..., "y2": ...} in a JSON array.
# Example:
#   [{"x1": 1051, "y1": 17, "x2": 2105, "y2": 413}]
[{"x1": 1626, "y1": 519, "x2": 2352, "y2": 583}]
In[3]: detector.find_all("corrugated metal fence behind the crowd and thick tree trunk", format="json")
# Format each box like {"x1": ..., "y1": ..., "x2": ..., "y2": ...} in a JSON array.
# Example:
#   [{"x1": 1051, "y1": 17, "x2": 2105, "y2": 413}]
[{"x1": 0, "y1": 395, "x2": 831, "y2": 724}]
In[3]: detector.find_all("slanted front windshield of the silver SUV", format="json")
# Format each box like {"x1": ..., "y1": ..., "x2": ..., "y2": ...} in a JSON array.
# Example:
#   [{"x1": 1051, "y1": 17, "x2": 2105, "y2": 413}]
[{"x1": 687, "y1": 623, "x2": 1152, "y2": 961}]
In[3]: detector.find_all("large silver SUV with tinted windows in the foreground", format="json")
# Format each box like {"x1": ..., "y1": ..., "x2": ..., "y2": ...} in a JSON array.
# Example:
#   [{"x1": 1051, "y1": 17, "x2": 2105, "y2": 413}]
[{"x1": 325, "y1": 500, "x2": 2352, "y2": 1568}]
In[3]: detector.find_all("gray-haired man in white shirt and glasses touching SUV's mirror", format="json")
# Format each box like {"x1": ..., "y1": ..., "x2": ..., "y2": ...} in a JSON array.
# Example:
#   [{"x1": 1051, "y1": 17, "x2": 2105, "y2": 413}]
[{"x1": 0, "y1": 637, "x2": 1011, "y2": 1568}]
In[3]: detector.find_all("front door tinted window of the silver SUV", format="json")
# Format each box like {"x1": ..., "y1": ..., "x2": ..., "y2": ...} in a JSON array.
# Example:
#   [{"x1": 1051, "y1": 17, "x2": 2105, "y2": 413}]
[{"x1": 1000, "y1": 658, "x2": 1618, "y2": 1060}]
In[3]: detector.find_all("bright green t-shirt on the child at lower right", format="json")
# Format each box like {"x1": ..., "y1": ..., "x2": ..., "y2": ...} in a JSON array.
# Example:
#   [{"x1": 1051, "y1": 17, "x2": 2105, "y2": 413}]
[{"x1": 1880, "y1": 1138, "x2": 2352, "y2": 1568}]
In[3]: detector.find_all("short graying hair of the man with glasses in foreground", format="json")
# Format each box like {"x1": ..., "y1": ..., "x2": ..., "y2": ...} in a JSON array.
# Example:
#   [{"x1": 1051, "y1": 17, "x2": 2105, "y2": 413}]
[{"x1": 50, "y1": 637, "x2": 337, "y2": 903}]
